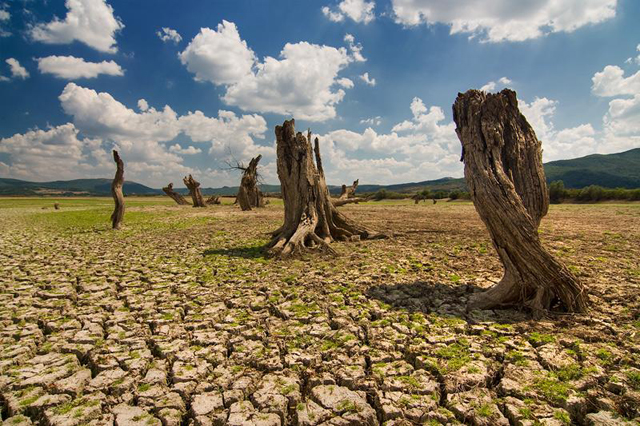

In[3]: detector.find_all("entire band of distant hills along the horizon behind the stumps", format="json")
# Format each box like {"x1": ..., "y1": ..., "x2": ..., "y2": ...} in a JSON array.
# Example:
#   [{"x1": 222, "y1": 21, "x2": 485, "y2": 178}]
[{"x1": 0, "y1": 148, "x2": 640, "y2": 195}]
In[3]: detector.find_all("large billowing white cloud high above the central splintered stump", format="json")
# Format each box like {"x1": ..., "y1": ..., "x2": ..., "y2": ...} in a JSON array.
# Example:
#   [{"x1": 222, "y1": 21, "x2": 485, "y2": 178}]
[{"x1": 180, "y1": 21, "x2": 364, "y2": 121}]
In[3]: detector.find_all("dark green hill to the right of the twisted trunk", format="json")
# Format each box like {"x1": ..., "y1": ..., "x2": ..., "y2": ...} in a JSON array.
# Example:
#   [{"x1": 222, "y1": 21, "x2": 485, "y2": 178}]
[{"x1": 544, "y1": 148, "x2": 640, "y2": 188}]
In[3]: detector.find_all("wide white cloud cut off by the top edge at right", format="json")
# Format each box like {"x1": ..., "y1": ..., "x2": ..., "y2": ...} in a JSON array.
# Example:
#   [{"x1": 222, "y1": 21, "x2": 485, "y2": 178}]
[{"x1": 392, "y1": 0, "x2": 617, "y2": 42}]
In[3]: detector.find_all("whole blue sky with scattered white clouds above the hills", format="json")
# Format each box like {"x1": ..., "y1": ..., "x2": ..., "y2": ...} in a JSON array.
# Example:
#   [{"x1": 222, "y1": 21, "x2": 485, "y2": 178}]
[{"x1": 0, "y1": 0, "x2": 640, "y2": 187}]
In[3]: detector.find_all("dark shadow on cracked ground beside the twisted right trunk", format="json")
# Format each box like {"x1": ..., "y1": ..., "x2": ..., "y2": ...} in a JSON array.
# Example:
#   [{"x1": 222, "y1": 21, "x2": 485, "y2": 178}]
[{"x1": 366, "y1": 281, "x2": 529, "y2": 323}]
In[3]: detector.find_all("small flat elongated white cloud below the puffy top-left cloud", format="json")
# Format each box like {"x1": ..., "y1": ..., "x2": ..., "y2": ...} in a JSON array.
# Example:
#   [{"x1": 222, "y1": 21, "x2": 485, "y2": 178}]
[{"x1": 37, "y1": 56, "x2": 124, "y2": 80}]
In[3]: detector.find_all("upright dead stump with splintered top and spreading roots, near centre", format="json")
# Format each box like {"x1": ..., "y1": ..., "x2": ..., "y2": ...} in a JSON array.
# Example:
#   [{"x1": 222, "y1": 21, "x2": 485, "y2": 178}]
[{"x1": 268, "y1": 119, "x2": 383, "y2": 257}]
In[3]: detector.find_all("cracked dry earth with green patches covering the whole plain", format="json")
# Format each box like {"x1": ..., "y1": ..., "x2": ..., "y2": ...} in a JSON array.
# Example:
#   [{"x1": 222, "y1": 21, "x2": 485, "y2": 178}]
[{"x1": 0, "y1": 198, "x2": 640, "y2": 426}]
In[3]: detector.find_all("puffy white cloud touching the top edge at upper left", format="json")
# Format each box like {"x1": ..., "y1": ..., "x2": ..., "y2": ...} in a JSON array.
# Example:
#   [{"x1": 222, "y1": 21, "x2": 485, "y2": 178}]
[{"x1": 29, "y1": 0, "x2": 124, "y2": 53}]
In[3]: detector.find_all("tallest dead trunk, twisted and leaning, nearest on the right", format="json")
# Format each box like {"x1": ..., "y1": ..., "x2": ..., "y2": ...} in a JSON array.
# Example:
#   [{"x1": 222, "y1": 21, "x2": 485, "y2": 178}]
[{"x1": 453, "y1": 89, "x2": 587, "y2": 317}]
